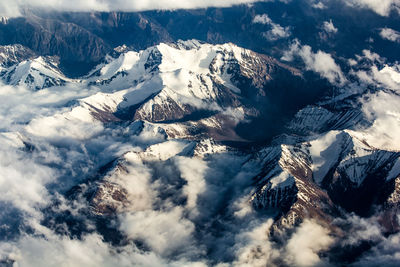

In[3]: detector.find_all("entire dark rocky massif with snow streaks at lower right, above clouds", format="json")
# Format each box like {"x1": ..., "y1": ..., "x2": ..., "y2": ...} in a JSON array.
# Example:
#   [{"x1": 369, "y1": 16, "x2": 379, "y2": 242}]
[{"x1": 251, "y1": 124, "x2": 400, "y2": 236}]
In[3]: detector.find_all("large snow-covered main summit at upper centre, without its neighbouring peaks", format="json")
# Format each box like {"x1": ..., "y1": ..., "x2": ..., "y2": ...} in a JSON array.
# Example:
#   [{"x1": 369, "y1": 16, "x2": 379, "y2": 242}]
[{"x1": 82, "y1": 40, "x2": 299, "y2": 125}]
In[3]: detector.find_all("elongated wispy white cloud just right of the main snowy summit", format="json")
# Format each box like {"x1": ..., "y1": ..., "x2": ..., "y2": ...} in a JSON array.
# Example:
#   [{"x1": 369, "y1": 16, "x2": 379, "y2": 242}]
[{"x1": 282, "y1": 40, "x2": 346, "y2": 85}]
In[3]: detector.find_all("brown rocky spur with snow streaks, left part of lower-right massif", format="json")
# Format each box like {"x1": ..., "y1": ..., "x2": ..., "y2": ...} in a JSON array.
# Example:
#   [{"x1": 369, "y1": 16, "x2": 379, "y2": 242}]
[{"x1": 251, "y1": 143, "x2": 339, "y2": 232}]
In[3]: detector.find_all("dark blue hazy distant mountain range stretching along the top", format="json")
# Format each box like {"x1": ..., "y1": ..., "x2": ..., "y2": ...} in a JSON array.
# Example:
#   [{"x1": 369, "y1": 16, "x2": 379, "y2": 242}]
[{"x1": 0, "y1": 0, "x2": 400, "y2": 76}]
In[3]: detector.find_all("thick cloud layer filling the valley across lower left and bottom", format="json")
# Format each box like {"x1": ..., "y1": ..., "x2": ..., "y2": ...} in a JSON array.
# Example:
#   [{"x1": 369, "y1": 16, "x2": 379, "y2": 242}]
[{"x1": 0, "y1": 72, "x2": 340, "y2": 267}]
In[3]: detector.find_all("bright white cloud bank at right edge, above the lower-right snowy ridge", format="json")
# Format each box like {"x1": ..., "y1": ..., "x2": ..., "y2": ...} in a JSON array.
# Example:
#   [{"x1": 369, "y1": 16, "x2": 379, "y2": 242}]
[{"x1": 350, "y1": 50, "x2": 400, "y2": 150}]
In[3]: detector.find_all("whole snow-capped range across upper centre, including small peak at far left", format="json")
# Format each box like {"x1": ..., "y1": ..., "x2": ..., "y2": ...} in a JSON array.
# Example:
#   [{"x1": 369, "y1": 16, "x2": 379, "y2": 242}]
[{"x1": 17, "y1": 40, "x2": 302, "y2": 143}]
